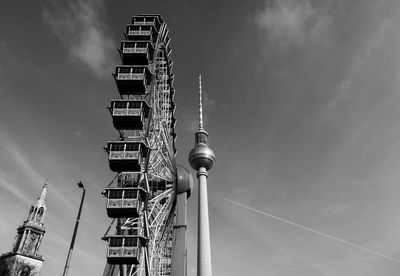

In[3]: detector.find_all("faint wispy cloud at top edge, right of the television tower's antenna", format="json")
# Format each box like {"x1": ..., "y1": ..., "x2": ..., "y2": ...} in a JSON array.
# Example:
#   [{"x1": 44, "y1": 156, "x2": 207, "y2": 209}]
[{"x1": 255, "y1": 0, "x2": 331, "y2": 50}]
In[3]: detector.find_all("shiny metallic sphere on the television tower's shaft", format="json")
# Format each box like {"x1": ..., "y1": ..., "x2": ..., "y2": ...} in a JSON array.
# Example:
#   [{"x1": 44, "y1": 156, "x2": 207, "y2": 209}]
[{"x1": 189, "y1": 143, "x2": 215, "y2": 171}]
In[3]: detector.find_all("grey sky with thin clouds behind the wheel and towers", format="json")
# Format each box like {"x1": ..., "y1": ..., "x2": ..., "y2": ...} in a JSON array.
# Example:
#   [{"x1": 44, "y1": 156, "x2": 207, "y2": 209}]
[{"x1": 0, "y1": 0, "x2": 400, "y2": 276}]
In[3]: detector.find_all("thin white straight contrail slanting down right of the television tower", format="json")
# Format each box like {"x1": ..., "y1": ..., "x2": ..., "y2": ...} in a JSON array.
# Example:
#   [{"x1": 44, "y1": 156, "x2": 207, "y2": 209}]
[{"x1": 224, "y1": 198, "x2": 400, "y2": 264}]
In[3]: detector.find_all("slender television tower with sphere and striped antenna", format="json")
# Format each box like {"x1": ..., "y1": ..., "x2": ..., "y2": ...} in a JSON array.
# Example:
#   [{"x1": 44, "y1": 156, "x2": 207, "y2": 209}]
[{"x1": 189, "y1": 75, "x2": 215, "y2": 276}]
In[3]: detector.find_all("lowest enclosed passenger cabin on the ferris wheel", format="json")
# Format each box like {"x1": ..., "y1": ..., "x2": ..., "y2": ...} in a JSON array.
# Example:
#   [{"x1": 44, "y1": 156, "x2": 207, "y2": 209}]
[{"x1": 107, "y1": 235, "x2": 144, "y2": 264}]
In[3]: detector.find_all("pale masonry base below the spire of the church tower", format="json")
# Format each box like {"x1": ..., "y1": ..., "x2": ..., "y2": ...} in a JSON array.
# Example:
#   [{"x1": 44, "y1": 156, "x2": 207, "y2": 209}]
[{"x1": 0, "y1": 252, "x2": 43, "y2": 276}]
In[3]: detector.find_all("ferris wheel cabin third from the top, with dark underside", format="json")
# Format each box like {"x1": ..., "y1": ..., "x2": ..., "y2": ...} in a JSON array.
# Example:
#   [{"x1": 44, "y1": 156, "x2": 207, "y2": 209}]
[{"x1": 118, "y1": 41, "x2": 154, "y2": 65}]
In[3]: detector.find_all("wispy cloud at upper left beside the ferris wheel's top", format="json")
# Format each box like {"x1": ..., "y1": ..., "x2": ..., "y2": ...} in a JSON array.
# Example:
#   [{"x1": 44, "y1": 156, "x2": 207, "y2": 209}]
[{"x1": 43, "y1": 0, "x2": 115, "y2": 77}]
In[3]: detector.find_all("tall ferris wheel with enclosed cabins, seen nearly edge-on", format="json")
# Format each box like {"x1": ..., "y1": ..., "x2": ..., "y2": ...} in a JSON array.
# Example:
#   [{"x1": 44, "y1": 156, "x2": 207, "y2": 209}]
[{"x1": 103, "y1": 15, "x2": 192, "y2": 276}]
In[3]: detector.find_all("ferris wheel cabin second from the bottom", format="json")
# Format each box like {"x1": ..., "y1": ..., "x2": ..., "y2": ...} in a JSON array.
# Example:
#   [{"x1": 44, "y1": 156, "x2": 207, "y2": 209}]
[{"x1": 105, "y1": 187, "x2": 146, "y2": 218}]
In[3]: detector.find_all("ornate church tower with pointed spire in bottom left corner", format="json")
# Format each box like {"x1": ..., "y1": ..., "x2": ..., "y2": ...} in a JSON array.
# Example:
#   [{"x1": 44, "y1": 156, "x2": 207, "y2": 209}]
[{"x1": 0, "y1": 182, "x2": 47, "y2": 276}]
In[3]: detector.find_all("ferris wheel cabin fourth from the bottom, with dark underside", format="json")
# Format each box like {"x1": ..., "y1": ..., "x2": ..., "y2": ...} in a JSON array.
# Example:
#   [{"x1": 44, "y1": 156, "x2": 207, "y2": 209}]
[{"x1": 109, "y1": 100, "x2": 150, "y2": 130}]
